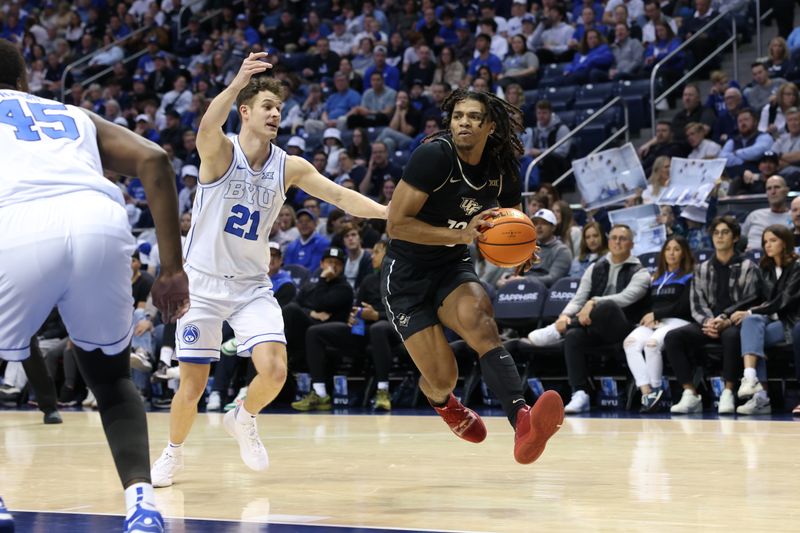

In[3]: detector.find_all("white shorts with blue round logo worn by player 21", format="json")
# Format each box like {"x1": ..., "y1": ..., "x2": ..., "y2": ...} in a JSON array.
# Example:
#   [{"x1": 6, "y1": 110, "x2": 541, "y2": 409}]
[{"x1": 175, "y1": 265, "x2": 286, "y2": 364}]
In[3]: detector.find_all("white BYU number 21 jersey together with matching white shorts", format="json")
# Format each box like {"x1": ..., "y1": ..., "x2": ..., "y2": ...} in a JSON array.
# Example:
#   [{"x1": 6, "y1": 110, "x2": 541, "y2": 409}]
[{"x1": 176, "y1": 136, "x2": 287, "y2": 363}]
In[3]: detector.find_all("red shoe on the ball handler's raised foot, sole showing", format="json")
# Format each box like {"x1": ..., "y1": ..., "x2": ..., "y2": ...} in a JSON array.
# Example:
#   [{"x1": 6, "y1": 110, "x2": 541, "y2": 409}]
[{"x1": 514, "y1": 390, "x2": 564, "y2": 465}]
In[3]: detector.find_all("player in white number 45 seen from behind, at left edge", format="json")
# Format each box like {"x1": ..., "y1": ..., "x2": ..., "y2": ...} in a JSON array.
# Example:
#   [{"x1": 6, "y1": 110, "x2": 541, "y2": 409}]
[{"x1": 0, "y1": 39, "x2": 189, "y2": 532}]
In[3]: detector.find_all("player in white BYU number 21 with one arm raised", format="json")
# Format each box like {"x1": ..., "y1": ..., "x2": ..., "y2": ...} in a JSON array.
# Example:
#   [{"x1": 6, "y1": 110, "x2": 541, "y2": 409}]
[{"x1": 152, "y1": 53, "x2": 386, "y2": 487}]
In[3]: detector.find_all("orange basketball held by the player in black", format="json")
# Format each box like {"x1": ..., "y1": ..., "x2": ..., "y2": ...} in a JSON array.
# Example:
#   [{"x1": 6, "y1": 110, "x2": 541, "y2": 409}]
[{"x1": 478, "y1": 208, "x2": 536, "y2": 268}]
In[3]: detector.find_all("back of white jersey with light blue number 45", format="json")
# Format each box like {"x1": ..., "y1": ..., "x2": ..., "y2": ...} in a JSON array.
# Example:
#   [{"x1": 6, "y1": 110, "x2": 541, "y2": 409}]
[{"x1": 0, "y1": 90, "x2": 125, "y2": 208}]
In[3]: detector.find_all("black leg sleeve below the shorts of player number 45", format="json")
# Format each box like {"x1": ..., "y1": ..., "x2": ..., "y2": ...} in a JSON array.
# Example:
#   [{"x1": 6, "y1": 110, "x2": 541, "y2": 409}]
[{"x1": 75, "y1": 348, "x2": 150, "y2": 487}]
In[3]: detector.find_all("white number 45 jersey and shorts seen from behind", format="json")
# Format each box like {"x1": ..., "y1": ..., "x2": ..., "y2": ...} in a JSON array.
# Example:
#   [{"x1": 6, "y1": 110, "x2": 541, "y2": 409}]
[{"x1": 0, "y1": 90, "x2": 136, "y2": 361}]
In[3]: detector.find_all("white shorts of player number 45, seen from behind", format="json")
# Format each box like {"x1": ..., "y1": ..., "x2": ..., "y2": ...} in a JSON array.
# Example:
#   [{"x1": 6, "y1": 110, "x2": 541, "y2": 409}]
[{"x1": 0, "y1": 192, "x2": 136, "y2": 361}]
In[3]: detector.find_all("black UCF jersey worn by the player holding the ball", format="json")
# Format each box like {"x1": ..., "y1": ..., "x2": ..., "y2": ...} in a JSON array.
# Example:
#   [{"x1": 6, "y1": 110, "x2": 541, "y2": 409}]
[{"x1": 388, "y1": 136, "x2": 522, "y2": 266}]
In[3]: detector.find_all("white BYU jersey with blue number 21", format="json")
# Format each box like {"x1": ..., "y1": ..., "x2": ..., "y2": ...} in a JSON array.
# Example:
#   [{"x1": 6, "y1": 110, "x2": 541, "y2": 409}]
[{"x1": 183, "y1": 135, "x2": 286, "y2": 282}]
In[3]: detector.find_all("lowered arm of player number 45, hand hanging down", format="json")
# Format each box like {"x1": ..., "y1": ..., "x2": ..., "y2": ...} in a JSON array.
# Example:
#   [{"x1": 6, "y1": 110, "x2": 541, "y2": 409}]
[{"x1": 84, "y1": 109, "x2": 189, "y2": 322}]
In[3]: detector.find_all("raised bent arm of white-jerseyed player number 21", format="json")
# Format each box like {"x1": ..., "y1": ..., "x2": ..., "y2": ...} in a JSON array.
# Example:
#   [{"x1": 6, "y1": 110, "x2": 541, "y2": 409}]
[{"x1": 197, "y1": 52, "x2": 272, "y2": 184}]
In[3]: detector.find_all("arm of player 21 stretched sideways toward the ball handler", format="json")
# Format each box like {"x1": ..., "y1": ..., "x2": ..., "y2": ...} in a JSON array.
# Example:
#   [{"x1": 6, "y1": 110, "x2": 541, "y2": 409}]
[{"x1": 286, "y1": 156, "x2": 386, "y2": 219}]
